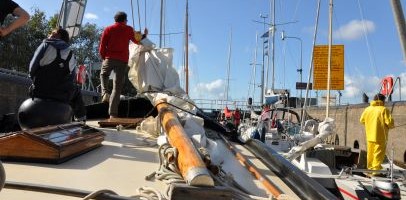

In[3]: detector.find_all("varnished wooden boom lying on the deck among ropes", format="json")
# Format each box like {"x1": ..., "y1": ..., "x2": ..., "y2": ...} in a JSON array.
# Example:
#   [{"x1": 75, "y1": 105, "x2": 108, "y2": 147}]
[{"x1": 156, "y1": 101, "x2": 214, "y2": 186}]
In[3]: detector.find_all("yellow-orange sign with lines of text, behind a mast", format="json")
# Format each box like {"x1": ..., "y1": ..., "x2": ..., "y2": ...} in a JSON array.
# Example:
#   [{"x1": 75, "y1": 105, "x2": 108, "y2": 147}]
[{"x1": 313, "y1": 45, "x2": 344, "y2": 90}]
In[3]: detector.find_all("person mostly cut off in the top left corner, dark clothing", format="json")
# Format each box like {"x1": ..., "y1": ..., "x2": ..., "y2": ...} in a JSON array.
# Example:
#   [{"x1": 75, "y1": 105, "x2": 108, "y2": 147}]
[{"x1": 0, "y1": 0, "x2": 30, "y2": 37}]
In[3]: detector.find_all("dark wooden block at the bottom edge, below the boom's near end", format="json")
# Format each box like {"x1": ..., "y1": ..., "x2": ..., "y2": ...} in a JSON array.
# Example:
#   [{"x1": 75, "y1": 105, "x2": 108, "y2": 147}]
[{"x1": 169, "y1": 184, "x2": 233, "y2": 200}]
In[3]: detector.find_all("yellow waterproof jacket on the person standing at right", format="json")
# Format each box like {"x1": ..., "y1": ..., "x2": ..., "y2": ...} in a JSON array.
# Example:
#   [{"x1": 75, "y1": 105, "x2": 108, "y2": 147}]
[{"x1": 359, "y1": 100, "x2": 394, "y2": 143}]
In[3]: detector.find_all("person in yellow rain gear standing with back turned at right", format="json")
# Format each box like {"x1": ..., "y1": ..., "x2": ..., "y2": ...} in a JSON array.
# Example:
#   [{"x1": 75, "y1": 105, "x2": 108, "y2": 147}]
[{"x1": 360, "y1": 94, "x2": 394, "y2": 175}]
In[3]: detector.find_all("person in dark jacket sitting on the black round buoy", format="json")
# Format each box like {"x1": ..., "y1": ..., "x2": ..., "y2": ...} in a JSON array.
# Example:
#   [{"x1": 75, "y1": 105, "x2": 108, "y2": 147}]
[{"x1": 29, "y1": 28, "x2": 86, "y2": 121}]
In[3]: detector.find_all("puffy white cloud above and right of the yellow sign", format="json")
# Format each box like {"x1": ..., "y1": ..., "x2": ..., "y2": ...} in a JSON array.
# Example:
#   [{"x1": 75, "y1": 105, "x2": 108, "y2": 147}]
[{"x1": 334, "y1": 20, "x2": 375, "y2": 40}]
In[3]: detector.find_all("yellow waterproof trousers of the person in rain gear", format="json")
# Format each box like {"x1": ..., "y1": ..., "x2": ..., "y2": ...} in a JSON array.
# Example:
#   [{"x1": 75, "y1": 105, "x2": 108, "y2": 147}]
[{"x1": 367, "y1": 141, "x2": 386, "y2": 170}]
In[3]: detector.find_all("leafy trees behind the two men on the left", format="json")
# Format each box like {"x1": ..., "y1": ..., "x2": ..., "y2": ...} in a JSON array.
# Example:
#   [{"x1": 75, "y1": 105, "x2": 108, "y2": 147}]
[{"x1": 0, "y1": 9, "x2": 136, "y2": 95}]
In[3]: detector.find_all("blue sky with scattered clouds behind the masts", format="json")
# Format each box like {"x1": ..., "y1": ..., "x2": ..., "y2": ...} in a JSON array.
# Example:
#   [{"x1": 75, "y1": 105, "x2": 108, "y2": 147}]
[{"x1": 16, "y1": 0, "x2": 406, "y2": 103}]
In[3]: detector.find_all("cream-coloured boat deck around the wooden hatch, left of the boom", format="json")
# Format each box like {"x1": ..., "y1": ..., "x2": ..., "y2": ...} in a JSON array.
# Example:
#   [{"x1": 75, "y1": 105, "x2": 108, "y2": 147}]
[{"x1": 0, "y1": 121, "x2": 166, "y2": 200}]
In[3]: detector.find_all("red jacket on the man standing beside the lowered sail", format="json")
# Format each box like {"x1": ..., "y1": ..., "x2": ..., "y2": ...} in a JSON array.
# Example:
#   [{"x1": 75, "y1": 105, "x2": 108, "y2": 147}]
[{"x1": 99, "y1": 22, "x2": 138, "y2": 63}]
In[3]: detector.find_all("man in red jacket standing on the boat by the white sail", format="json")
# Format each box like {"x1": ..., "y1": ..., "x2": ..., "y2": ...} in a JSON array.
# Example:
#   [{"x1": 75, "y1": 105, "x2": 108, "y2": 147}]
[{"x1": 99, "y1": 12, "x2": 148, "y2": 118}]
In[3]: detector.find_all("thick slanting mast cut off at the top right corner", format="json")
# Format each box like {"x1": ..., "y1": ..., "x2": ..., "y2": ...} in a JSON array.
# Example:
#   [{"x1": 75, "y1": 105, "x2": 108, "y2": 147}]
[{"x1": 391, "y1": 0, "x2": 406, "y2": 62}]
